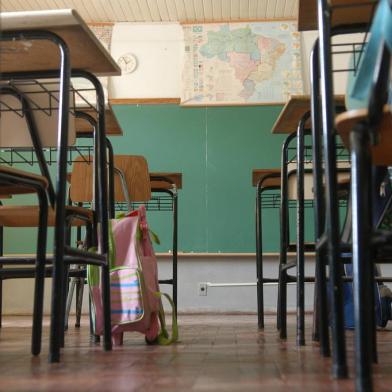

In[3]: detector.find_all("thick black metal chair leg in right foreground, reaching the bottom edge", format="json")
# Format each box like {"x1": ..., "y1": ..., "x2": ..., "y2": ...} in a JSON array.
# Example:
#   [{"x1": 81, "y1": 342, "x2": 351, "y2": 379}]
[{"x1": 350, "y1": 124, "x2": 374, "y2": 392}]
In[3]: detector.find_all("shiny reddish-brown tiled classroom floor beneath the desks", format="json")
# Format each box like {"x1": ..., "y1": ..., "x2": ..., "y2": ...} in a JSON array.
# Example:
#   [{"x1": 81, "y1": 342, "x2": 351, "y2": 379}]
[{"x1": 0, "y1": 315, "x2": 392, "y2": 392}]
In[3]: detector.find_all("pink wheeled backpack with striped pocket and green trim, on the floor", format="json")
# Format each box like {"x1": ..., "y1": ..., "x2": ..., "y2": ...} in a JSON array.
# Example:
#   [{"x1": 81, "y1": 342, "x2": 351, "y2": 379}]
[{"x1": 87, "y1": 206, "x2": 178, "y2": 345}]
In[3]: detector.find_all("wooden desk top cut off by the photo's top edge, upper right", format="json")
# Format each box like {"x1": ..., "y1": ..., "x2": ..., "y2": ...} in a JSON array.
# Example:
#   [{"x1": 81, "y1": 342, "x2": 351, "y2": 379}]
[{"x1": 298, "y1": 0, "x2": 378, "y2": 31}]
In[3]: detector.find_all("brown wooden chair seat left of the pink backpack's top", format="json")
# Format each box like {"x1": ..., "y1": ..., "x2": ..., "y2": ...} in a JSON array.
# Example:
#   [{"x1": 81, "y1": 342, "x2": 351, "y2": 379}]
[{"x1": 0, "y1": 205, "x2": 93, "y2": 227}]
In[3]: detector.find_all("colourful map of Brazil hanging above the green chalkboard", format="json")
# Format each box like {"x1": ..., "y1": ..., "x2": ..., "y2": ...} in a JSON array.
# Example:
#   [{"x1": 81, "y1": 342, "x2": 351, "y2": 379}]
[{"x1": 181, "y1": 22, "x2": 303, "y2": 105}]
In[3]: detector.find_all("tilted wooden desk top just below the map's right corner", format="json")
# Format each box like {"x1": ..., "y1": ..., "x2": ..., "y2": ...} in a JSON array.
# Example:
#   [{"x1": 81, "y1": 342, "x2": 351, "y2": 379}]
[{"x1": 272, "y1": 95, "x2": 344, "y2": 133}]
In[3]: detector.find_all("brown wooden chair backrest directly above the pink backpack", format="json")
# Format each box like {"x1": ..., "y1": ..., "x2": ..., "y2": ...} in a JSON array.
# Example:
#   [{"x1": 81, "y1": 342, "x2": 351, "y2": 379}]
[{"x1": 70, "y1": 155, "x2": 151, "y2": 203}]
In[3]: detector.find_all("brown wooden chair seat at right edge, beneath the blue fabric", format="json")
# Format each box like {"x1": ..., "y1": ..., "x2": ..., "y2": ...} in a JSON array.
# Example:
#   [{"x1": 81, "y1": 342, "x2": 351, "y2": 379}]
[{"x1": 335, "y1": 106, "x2": 392, "y2": 166}]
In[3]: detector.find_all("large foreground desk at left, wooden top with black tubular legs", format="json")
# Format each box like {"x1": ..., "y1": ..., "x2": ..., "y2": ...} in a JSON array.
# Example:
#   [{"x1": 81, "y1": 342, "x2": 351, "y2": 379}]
[{"x1": 0, "y1": 10, "x2": 121, "y2": 362}]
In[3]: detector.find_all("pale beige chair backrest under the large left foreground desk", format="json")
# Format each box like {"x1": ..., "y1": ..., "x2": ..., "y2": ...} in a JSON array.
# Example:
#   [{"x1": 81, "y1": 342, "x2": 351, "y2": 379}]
[{"x1": 0, "y1": 80, "x2": 76, "y2": 148}]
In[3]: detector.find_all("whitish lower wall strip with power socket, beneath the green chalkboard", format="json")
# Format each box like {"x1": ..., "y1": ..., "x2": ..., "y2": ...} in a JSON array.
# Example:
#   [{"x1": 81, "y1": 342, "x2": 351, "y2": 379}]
[{"x1": 3, "y1": 256, "x2": 314, "y2": 314}]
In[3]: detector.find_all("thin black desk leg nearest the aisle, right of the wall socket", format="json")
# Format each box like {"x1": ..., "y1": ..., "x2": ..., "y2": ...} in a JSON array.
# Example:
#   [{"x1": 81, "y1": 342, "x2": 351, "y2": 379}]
[{"x1": 256, "y1": 183, "x2": 264, "y2": 329}]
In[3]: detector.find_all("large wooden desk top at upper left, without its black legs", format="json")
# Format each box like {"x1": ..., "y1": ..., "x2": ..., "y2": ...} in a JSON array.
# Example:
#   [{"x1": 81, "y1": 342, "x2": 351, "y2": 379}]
[{"x1": 0, "y1": 10, "x2": 121, "y2": 76}]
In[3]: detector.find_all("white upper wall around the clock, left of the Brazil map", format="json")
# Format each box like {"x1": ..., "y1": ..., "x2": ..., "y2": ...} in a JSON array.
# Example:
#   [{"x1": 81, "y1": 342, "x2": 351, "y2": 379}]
[{"x1": 110, "y1": 23, "x2": 184, "y2": 98}]
